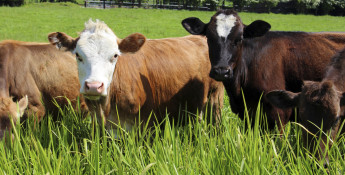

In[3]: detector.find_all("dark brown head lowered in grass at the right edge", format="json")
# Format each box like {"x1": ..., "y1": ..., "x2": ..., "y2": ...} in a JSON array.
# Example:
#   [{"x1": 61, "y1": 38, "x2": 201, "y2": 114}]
[{"x1": 266, "y1": 81, "x2": 345, "y2": 163}]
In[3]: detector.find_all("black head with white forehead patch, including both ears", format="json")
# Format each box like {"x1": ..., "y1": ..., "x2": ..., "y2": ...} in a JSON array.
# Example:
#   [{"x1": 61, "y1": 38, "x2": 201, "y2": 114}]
[{"x1": 182, "y1": 10, "x2": 271, "y2": 81}]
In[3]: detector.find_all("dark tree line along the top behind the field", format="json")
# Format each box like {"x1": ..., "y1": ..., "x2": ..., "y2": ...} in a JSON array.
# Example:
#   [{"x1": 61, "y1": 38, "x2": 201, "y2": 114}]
[{"x1": 0, "y1": 0, "x2": 345, "y2": 16}]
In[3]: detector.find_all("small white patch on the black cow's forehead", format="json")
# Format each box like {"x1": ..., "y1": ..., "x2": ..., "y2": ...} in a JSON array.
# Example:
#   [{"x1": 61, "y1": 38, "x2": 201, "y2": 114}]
[{"x1": 216, "y1": 13, "x2": 236, "y2": 38}]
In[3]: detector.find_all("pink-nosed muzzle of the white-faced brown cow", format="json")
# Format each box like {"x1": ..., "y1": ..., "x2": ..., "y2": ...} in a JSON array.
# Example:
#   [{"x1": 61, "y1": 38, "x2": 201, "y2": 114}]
[{"x1": 84, "y1": 81, "x2": 105, "y2": 100}]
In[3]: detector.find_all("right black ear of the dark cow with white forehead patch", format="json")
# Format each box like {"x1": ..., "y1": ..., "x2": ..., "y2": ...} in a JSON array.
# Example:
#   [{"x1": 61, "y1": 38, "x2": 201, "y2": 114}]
[{"x1": 243, "y1": 20, "x2": 271, "y2": 38}]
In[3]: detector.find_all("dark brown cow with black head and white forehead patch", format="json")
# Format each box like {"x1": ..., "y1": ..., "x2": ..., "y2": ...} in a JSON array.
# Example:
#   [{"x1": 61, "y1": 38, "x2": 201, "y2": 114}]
[{"x1": 182, "y1": 10, "x2": 345, "y2": 131}]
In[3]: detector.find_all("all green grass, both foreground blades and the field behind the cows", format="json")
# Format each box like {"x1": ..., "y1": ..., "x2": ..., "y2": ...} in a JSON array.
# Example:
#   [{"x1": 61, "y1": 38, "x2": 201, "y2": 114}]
[{"x1": 0, "y1": 3, "x2": 345, "y2": 175}]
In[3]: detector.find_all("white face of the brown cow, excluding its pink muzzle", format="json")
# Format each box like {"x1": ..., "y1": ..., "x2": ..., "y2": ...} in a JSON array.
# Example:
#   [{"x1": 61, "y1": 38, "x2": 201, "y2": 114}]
[{"x1": 75, "y1": 20, "x2": 121, "y2": 96}]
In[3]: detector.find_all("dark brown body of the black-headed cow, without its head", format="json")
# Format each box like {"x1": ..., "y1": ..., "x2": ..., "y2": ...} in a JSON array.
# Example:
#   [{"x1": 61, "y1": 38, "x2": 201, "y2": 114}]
[{"x1": 228, "y1": 32, "x2": 345, "y2": 128}]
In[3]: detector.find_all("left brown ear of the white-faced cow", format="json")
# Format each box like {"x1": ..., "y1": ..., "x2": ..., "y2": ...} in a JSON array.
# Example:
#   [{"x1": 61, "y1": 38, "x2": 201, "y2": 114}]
[{"x1": 48, "y1": 32, "x2": 79, "y2": 52}]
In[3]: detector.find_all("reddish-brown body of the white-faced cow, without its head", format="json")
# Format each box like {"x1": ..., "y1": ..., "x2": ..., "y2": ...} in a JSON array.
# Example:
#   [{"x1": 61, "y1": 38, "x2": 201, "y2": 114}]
[{"x1": 95, "y1": 36, "x2": 224, "y2": 129}]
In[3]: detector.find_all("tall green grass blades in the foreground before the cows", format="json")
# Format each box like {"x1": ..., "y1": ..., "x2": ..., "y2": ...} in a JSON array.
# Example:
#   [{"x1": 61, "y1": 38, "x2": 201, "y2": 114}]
[{"x1": 0, "y1": 95, "x2": 345, "y2": 174}]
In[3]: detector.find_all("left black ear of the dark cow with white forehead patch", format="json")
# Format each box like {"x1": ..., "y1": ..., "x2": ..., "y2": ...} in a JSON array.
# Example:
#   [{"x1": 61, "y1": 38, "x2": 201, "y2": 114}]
[{"x1": 182, "y1": 17, "x2": 207, "y2": 35}]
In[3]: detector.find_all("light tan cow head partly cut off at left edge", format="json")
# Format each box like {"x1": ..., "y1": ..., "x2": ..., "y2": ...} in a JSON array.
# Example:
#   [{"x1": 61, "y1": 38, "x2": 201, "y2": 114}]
[{"x1": 0, "y1": 96, "x2": 28, "y2": 139}]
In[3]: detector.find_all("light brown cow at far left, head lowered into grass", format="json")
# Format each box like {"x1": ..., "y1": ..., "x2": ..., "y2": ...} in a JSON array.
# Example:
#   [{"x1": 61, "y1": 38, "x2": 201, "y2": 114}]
[{"x1": 0, "y1": 40, "x2": 87, "y2": 138}]
